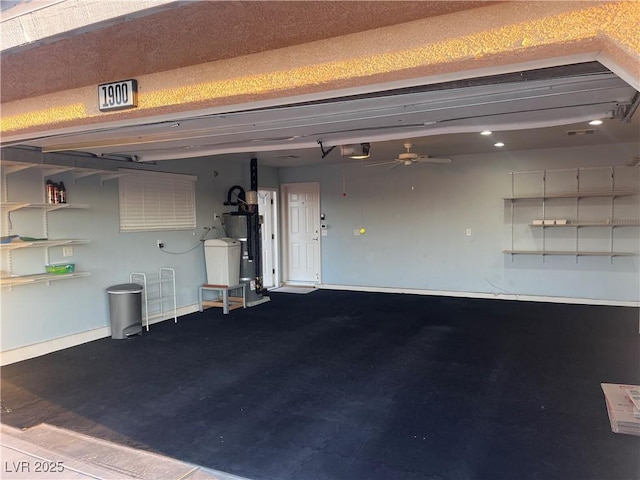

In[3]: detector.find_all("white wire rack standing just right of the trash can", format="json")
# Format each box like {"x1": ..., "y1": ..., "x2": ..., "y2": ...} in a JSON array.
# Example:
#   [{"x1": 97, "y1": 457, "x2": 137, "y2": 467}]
[{"x1": 129, "y1": 267, "x2": 178, "y2": 331}]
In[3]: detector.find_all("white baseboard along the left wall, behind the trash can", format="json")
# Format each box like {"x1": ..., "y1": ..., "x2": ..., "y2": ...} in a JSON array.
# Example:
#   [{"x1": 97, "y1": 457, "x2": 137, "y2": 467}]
[{"x1": 0, "y1": 304, "x2": 199, "y2": 366}]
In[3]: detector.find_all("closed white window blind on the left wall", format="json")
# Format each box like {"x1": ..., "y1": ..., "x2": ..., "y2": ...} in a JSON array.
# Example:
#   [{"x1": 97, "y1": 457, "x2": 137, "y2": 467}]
[{"x1": 118, "y1": 169, "x2": 197, "y2": 232}]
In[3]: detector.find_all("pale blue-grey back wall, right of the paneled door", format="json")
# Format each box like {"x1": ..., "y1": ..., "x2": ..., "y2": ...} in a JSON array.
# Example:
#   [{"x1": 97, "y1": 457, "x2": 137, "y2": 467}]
[{"x1": 280, "y1": 144, "x2": 640, "y2": 301}]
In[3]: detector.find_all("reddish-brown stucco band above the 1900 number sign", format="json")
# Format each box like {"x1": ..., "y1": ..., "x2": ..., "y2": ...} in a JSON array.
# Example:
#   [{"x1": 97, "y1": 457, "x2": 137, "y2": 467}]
[{"x1": 0, "y1": 0, "x2": 496, "y2": 103}]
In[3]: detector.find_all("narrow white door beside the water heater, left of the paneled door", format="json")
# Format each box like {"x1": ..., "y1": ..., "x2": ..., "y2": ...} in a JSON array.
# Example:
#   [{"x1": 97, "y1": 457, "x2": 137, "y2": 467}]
[{"x1": 258, "y1": 189, "x2": 279, "y2": 288}]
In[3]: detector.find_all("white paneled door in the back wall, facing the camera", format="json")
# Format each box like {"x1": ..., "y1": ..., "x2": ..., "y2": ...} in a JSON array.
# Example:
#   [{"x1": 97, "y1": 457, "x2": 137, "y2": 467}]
[{"x1": 283, "y1": 183, "x2": 320, "y2": 283}]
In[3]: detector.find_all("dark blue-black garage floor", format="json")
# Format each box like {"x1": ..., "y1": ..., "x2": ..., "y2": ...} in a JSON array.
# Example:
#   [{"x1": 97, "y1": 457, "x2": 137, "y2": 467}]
[{"x1": 2, "y1": 290, "x2": 640, "y2": 480}]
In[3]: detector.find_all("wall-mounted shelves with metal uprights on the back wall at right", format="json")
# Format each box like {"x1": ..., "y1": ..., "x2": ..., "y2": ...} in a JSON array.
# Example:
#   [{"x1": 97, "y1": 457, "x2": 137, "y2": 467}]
[{"x1": 504, "y1": 166, "x2": 640, "y2": 261}]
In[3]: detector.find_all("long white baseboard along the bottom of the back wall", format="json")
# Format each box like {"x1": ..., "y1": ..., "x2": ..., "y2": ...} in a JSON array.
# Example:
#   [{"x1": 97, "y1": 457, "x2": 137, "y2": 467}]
[{"x1": 317, "y1": 284, "x2": 640, "y2": 307}]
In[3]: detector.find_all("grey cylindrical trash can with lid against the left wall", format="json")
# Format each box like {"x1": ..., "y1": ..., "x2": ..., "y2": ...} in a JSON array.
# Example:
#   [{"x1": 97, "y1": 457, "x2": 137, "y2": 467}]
[{"x1": 107, "y1": 283, "x2": 143, "y2": 339}]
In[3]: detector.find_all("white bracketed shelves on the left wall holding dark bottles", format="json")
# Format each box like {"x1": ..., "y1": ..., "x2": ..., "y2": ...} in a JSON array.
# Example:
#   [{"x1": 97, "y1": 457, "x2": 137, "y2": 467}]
[{"x1": 0, "y1": 160, "x2": 104, "y2": 288}]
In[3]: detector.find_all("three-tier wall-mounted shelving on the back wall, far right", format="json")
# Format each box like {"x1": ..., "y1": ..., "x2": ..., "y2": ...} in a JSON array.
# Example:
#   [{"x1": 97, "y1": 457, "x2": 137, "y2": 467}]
[{"x1": 503, "y1": 165, "x2": 640, "y2": 261}]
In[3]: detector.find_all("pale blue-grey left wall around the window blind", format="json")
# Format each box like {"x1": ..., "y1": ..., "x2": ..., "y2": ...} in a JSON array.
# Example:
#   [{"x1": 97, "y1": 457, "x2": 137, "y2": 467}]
[{"x1": 1, "y1": 149, "x2": 277, "y2": 351}]
